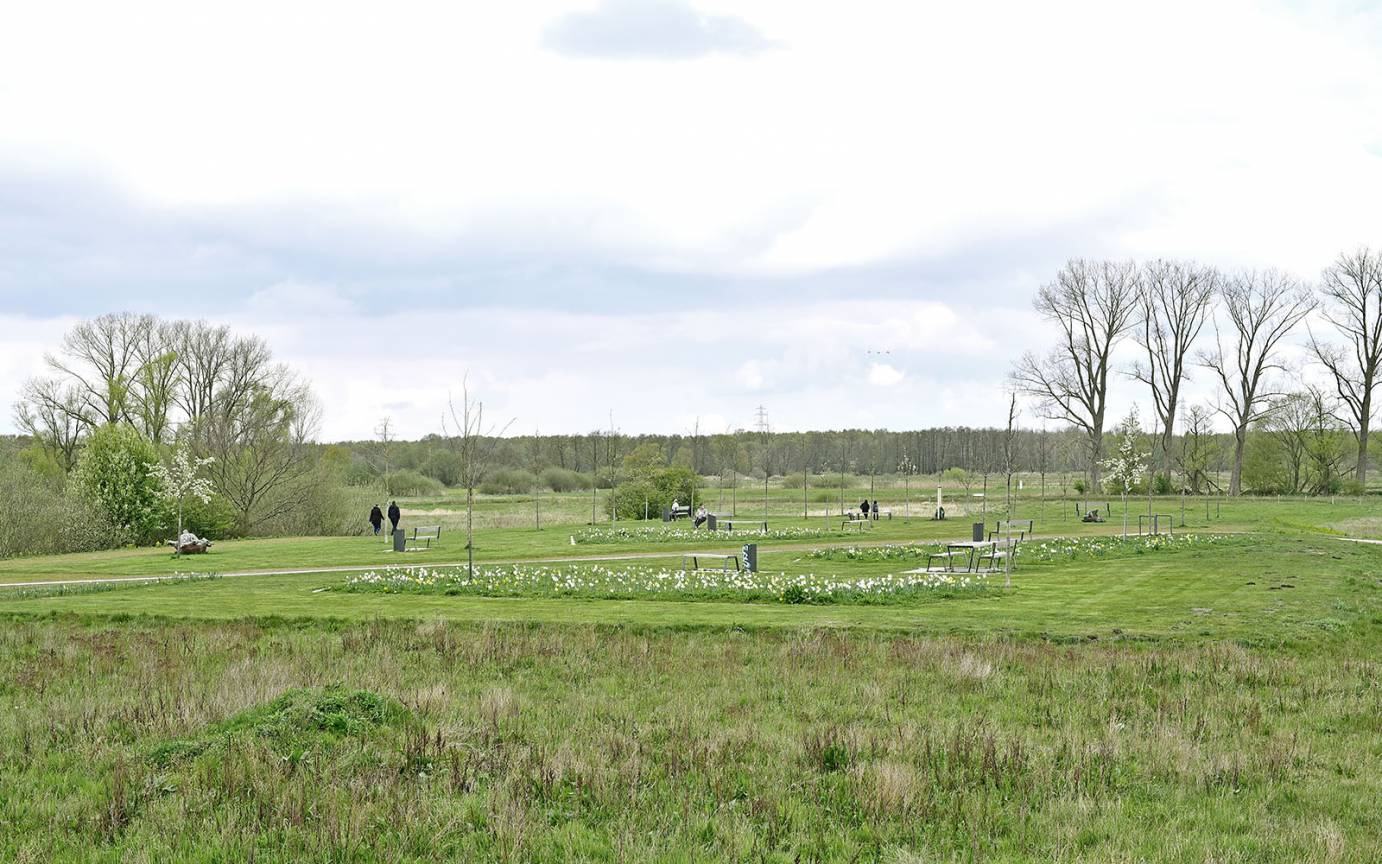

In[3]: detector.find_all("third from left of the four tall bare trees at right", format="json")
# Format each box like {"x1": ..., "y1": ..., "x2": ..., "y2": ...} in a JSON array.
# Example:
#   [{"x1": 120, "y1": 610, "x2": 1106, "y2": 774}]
[{"x1": 1200, "y1": 270, "x2": 1314, "y2": 495}]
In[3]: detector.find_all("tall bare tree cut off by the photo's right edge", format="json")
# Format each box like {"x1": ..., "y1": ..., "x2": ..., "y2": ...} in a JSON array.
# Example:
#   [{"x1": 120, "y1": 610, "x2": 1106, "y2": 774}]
[{"x1": 1310, "y1": 247, "x2": 1382, "y2": 485}]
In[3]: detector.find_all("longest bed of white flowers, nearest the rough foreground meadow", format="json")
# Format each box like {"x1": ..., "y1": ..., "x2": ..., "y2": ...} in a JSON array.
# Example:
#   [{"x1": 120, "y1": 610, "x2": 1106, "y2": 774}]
[{"x1": 328, "y1": 564, "x2": 987, "y2": 603}]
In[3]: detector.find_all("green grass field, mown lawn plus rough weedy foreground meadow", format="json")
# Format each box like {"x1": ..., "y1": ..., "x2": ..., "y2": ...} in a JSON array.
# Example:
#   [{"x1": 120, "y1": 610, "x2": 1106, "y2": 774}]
[{"x1": 0, "y1": 489, "x2": 1382, "y2": 864}]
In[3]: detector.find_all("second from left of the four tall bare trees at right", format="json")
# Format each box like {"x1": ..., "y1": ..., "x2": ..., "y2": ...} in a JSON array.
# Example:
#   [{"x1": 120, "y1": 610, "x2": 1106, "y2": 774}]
[{"x1": 1132, "y1": 260, "x2": 1218, "y2": 481}]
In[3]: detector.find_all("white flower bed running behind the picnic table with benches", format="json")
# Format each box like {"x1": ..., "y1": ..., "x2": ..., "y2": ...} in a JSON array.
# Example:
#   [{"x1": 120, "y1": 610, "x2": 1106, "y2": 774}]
[{"x1": 804, "y1": 534, "x2": 1245, "y2": 564}]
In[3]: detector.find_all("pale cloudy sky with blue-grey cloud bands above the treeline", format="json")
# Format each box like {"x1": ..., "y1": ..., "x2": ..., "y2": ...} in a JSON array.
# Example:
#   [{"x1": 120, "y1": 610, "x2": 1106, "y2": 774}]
[{"x1": 0, "y1": 0, "x2": 1382, "y2": 438}]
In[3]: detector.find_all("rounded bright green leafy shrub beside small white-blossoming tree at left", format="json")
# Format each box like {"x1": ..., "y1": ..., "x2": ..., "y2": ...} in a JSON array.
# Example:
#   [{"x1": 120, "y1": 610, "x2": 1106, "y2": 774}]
[{"x1": 75, "y1": 423, "x2": 167, "y2": 542}]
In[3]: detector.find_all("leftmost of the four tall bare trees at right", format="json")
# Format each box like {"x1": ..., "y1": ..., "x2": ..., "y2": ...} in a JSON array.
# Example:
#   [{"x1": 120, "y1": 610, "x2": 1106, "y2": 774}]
[{"x1": 1013, "y1": 259, "x2": 1137, "y2": 487}]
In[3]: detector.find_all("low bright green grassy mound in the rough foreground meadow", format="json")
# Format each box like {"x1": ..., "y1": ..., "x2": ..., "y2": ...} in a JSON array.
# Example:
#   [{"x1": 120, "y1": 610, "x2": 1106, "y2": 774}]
[{"x1": 149, "y1": 686, "x2": 412, "y2": 767}]
